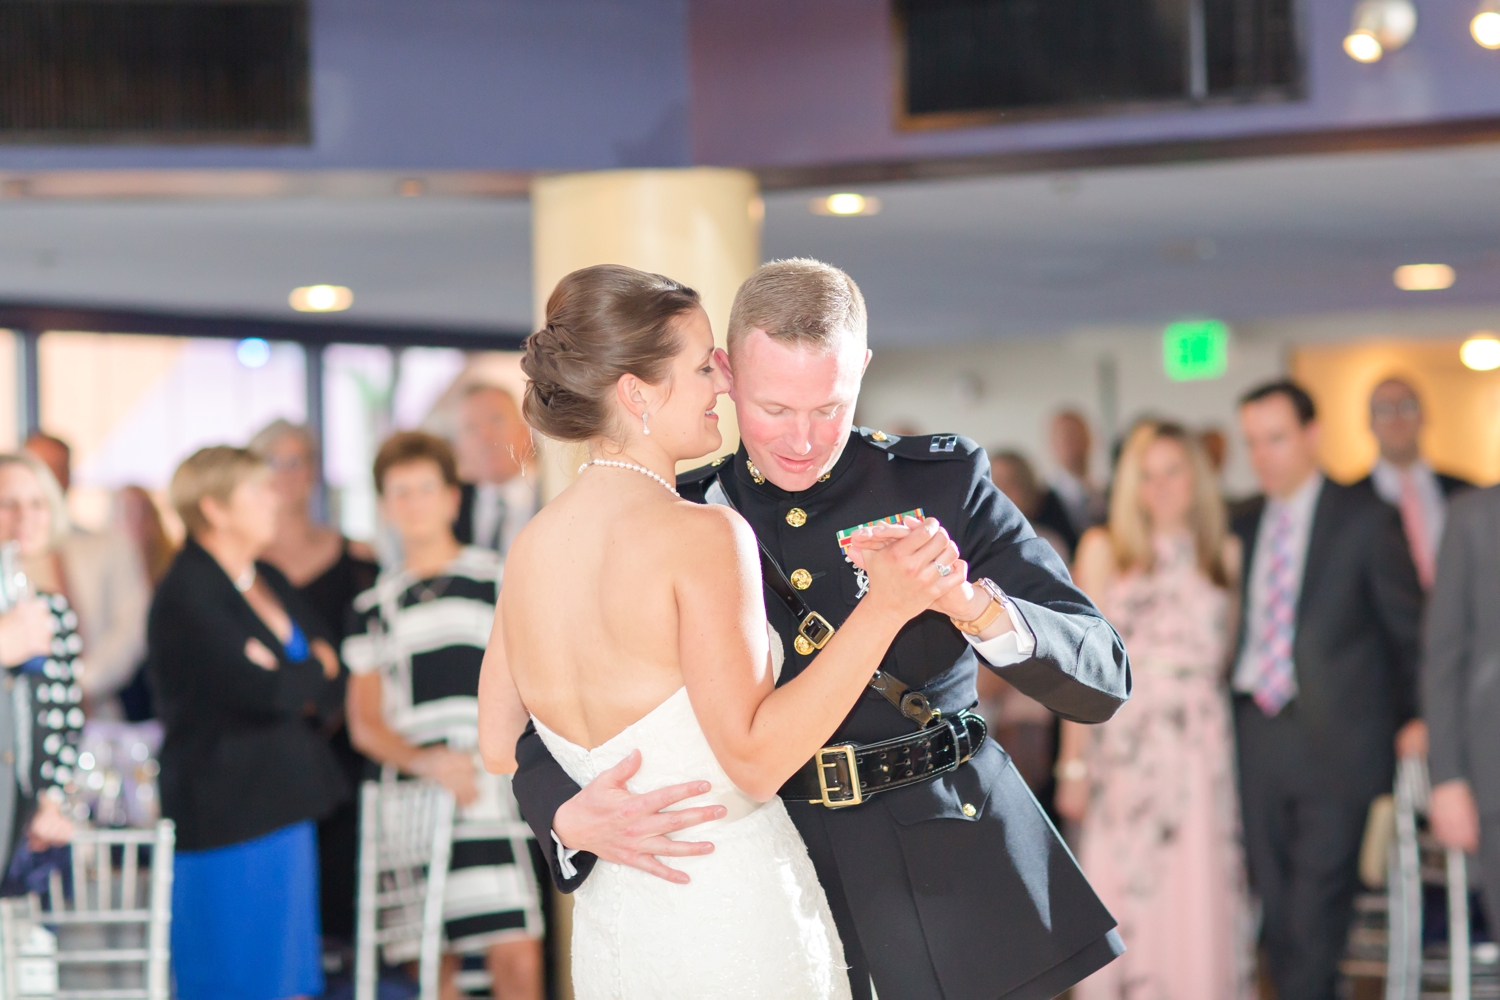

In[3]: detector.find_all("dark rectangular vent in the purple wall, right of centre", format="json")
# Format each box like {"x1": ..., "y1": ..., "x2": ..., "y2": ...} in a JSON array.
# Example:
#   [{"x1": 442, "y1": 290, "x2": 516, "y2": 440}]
[{"x1": 894, "y1": 0, "x2": 1302, "y2": 127}]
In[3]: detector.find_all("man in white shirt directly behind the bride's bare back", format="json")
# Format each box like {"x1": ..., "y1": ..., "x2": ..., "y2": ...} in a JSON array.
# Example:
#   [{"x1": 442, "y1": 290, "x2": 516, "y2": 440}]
[{"x1": 453, "y1": 384, "x2": 537, "y2": 556}]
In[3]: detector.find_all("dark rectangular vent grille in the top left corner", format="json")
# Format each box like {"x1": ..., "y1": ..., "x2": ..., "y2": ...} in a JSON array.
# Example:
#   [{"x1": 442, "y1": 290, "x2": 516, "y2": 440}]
[{"x1": 0, "y1": 0, "x2": 311, "y2": 144}]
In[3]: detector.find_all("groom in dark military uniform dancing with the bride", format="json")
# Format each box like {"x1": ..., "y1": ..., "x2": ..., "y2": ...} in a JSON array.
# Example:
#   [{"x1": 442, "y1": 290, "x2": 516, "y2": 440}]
[{"x1": 515, "y1": 259, "x2": 1131, "y2": 1000}]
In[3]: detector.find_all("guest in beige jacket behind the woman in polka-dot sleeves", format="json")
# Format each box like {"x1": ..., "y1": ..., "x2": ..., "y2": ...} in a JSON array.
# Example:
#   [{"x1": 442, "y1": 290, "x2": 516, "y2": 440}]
[{"x1": 26, "y1": 433, "x2": 152, "y2": 718}]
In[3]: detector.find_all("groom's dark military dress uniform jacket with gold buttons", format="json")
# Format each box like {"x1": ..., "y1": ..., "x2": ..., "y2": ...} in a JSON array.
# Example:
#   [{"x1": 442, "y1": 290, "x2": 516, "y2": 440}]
[{"x1": 515, "y1": 429, "x2": 1131, "y2": 1000}]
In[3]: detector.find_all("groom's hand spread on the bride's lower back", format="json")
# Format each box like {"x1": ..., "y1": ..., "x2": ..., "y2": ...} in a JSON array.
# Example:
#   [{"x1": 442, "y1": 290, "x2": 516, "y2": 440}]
[{"x1": 552, "y1": 750, "x2": 728, "y2": 885}]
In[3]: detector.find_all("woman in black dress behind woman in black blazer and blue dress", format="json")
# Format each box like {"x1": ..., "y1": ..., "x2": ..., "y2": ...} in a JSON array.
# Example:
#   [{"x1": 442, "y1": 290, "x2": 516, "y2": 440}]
[{"x1": 251, "y1": 420, "x2": 380, "y2": 954}]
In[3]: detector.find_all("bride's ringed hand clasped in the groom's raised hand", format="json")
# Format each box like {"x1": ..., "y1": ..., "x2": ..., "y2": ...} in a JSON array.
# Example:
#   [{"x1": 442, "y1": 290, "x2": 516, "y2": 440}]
[{"x1": 849, "y1": 517, "x2": 969, "y2": 621}]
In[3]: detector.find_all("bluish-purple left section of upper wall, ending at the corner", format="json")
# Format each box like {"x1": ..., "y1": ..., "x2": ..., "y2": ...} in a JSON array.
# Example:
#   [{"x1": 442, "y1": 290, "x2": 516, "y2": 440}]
[{"x1": 0, "y1": 0, "x2": 689, "y2": 171}]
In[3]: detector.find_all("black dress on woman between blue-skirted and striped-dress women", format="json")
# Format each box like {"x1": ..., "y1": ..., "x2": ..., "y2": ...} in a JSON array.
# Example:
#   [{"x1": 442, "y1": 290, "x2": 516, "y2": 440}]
[{"x1": 299, "y1": 538, "x2": 380, "y2": 942}]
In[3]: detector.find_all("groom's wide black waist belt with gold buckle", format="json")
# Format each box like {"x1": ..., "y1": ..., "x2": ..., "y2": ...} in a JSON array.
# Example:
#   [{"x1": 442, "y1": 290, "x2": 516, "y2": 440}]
[{"x1": 780, "y1": 712, "x2": 989, "y2": 810}]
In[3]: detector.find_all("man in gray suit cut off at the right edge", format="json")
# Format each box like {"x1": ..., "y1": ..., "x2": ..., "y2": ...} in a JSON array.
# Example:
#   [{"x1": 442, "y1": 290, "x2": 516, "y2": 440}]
[{"x1": 1421, "y1": 486, "x2": 1500, "y2": 922}]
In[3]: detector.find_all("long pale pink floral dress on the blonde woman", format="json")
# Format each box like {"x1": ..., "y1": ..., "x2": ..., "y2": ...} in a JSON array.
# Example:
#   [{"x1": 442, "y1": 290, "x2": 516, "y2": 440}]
[{"x1": 1073, "y1": 537, "x2": 1253, "y2": 1000}]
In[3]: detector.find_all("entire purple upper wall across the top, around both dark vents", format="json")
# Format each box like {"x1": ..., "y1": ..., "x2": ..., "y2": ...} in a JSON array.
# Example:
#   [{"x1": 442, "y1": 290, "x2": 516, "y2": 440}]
[{"x1": 0, "y1": 0, "x2": 1500, "y2": 172}]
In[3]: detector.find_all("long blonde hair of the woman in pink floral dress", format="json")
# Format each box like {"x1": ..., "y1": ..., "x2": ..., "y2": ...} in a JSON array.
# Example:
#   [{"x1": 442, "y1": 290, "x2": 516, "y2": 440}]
[{"x1": 1109, "y1": 420, "x2": 1230, "y2": 586}]
